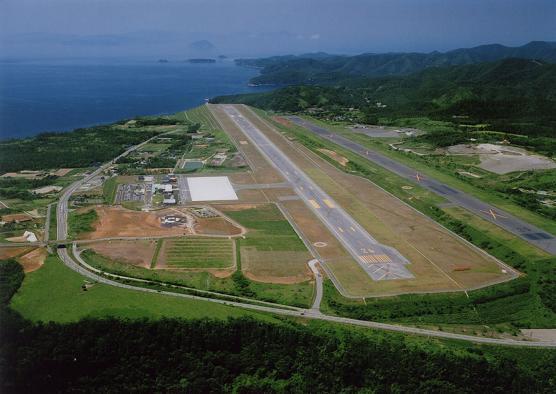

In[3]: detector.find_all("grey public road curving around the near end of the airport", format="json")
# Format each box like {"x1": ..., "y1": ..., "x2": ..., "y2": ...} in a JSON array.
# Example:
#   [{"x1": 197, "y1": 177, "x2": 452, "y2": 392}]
[{"x1": 47, "y1": 106, "x2": 556, "y2": 348}]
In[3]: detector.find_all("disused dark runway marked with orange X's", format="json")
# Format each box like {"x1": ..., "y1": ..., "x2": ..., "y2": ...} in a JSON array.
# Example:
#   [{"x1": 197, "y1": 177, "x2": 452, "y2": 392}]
[{"x1": 288, "y1": 116, "x2": 556, "y2": 255}]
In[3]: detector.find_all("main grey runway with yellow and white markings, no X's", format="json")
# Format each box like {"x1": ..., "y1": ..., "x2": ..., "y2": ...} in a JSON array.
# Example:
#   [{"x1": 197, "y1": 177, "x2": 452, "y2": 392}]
[{"x1": 223, "y1": 105, "x2": 413, "y2": 280}]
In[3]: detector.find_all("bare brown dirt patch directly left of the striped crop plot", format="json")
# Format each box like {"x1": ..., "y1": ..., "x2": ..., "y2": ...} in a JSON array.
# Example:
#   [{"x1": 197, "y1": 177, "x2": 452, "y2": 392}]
[{"x1": 89, "y1": 240, "x2": 156, "y2": 268}]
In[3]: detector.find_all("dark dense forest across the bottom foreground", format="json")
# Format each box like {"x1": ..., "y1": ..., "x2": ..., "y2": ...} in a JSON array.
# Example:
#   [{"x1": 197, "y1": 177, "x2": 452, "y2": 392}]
[{"x1": 0, "y1": 260, "x2": 556, "y2": 393}]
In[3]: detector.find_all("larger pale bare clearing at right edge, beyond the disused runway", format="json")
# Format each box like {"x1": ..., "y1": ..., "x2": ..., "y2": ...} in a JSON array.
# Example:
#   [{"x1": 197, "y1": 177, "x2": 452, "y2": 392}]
[{"x1": 446, "y1": 144, "x2": 556, "y2": 174}]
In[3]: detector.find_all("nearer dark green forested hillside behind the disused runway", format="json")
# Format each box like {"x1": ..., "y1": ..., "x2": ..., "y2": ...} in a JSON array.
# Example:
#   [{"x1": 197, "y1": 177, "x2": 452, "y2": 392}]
[{"x1": 212, "y1": 59, "x2": 556, "y2": 137}]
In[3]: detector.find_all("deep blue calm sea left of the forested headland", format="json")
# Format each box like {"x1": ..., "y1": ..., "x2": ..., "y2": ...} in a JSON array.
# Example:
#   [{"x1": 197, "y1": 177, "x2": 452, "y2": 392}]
[{"x1": 0, "y1": 62, "x2": 270, "y2": 139}]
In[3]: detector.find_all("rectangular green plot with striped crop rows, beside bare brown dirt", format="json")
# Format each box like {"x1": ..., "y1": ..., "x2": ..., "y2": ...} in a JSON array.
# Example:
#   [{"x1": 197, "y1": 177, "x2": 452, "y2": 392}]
[{"x1": 156, "y1": 238, "x2": 235, "y2": 269}]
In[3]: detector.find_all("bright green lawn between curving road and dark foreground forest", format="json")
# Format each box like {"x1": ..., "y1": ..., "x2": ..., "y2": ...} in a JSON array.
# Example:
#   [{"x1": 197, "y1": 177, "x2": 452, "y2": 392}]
[{"x1": 11, "y1": 256, "x2": 274, "y2": 322}]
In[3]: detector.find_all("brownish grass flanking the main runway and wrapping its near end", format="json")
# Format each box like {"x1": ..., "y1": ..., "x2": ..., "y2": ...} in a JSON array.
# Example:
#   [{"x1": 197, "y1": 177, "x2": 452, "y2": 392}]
[{"x1": 231, "y1": 107, "x2": 509, "y2": 296}]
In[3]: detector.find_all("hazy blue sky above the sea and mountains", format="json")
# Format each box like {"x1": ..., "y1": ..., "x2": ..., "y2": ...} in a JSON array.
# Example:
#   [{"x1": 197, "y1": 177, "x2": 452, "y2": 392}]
[{"x1": 0, "y1": 0, "x2": 556, "y2": 59}]
